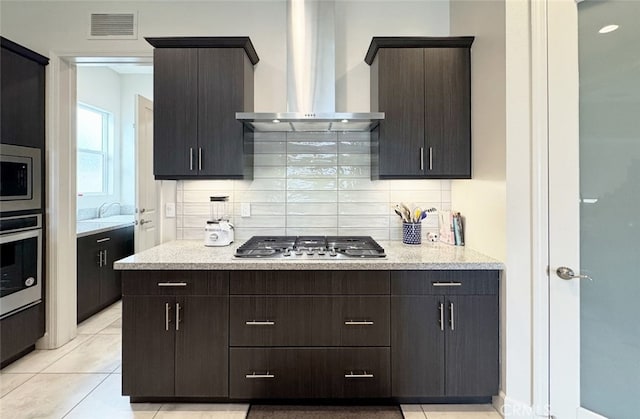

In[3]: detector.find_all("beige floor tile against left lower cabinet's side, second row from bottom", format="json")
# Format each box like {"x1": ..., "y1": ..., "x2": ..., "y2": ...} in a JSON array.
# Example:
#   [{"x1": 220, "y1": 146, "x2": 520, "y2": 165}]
[{"x1": 42, "y1": 335, "x2": 122, "y2": 374}]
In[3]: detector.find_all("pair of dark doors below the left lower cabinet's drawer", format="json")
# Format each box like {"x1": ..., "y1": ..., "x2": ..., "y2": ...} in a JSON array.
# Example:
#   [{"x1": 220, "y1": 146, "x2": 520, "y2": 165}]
[{"x1": 122, "y1": 296, "x2": 229, "y2": 397}]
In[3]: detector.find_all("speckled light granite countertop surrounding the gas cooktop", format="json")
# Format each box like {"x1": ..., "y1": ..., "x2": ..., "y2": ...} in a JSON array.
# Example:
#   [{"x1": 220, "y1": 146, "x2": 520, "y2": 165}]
[{"x1": 114, "y1": 240, "x2": 504, "y2": 270}]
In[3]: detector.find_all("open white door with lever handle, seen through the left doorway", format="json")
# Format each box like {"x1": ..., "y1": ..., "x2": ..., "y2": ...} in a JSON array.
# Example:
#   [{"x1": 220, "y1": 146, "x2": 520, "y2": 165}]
[{"x1": 135, "y1": 95, "x2": 160, "y2": 253}]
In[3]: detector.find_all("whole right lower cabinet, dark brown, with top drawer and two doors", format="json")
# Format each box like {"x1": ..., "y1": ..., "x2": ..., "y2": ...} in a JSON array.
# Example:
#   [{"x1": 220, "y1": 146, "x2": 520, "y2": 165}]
[{"x1": 391, "y1": 271, "x2": 499, "y2": 399}]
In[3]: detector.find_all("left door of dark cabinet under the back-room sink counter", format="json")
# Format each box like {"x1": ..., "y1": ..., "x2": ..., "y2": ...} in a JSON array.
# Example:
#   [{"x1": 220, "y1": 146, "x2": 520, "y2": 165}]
[{"x1": 76, "y1": 235, "x2": 101, "y2": 323}]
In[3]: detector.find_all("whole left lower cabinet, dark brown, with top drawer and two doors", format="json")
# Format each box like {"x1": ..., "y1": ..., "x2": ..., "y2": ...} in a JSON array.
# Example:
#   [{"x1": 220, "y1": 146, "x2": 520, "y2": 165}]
[{"x1": 122, "y1": 271, "x2": 229, "y2": 398}]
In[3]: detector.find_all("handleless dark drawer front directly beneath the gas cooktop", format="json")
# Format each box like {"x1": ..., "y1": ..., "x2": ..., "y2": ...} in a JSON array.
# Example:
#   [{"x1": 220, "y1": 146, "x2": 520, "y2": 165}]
[{"x1": 230, "y1": 271, "x2": 389, "y2": 295}]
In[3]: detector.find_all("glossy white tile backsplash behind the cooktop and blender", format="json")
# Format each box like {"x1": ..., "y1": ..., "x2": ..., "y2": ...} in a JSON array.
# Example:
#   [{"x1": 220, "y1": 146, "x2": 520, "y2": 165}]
[{"x1": 176, "y1": 132, "x2": 451, "y2": 244}]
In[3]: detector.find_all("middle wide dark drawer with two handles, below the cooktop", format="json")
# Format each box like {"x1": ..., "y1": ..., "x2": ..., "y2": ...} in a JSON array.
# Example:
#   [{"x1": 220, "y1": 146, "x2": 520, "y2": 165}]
[{"x1": 230, "y1": 296, "x2": 390, "y2": 346}]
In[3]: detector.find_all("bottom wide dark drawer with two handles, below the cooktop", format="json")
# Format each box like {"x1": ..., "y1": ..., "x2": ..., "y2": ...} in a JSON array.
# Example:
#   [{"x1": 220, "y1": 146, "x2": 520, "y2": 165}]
[{"x1": 229, "y1": 348, "x2": 391, "y2": 399}]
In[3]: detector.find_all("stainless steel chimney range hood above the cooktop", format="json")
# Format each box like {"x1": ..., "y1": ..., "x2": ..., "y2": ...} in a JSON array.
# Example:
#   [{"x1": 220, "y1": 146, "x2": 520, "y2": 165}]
[{"x1": 236, "y1": 0, "x2": 384, "y2": 132}]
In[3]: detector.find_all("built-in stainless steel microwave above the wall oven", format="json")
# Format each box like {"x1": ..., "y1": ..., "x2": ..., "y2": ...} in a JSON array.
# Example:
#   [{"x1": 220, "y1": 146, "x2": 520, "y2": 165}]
[{"x1": 0, "y1": 144, "x2": 42, "y2": 212}]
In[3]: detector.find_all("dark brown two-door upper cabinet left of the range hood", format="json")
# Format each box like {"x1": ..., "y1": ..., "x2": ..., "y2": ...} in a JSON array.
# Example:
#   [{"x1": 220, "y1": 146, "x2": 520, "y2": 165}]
[{"x1": 146, "y1": 37, "x2": 259, "y2": 179}]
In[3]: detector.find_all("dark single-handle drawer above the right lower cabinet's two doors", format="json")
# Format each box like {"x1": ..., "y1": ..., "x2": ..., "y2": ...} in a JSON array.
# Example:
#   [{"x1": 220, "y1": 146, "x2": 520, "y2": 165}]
[{"x1": 391, "y1": 270, "x2": 499, "y2": 295}]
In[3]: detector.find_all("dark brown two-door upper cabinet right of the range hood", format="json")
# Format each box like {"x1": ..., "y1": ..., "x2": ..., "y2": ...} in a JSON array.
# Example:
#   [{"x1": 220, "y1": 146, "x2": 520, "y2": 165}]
[{"x1": 365, "y1": 36, "x2": 474, "y2": 179}]
